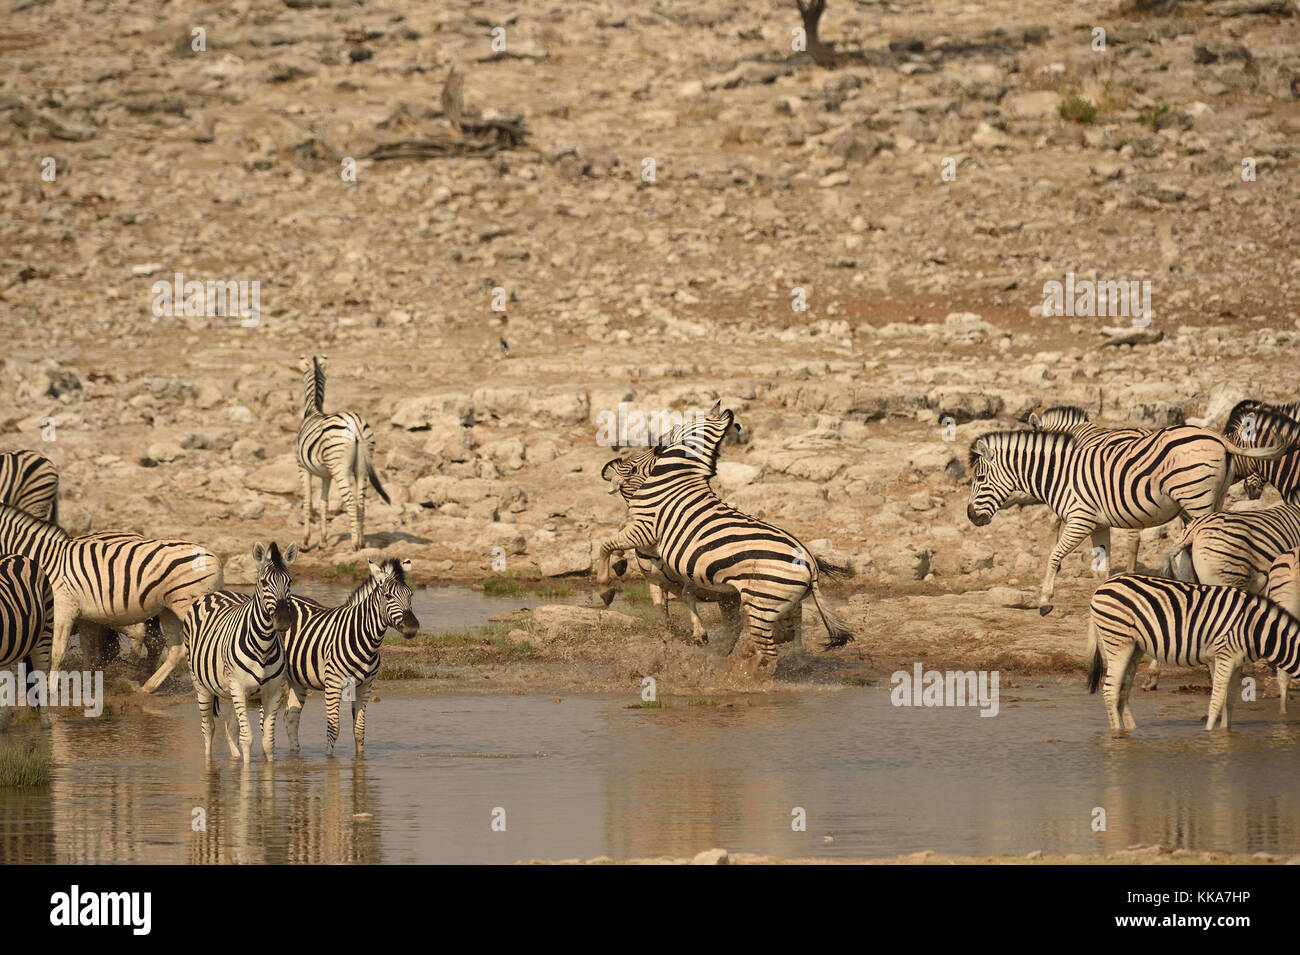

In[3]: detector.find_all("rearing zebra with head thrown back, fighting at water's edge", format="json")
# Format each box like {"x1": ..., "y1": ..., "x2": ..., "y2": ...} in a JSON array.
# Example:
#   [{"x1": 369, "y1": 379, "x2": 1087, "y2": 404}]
[{"x1": 597, "y1": 403, "x2": 853, "y2": 667}]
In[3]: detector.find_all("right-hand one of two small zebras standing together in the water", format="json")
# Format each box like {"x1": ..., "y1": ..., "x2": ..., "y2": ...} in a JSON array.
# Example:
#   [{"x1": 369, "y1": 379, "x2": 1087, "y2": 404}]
[{"x1": 285, "y1": 557, "x2": 420, "y2": 756}]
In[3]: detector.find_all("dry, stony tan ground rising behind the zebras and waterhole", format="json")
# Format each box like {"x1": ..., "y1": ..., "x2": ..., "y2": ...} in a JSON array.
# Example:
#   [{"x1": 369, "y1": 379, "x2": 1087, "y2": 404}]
[{"x1": 0, "y1": 0, "x2": 1300, "y2": 691}]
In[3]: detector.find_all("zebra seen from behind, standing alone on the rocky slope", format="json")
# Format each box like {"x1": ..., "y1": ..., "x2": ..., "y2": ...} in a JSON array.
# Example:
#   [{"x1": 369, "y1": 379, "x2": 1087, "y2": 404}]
[{"x1": 296, "y1": 355, "x2": 391, "y2": 551}]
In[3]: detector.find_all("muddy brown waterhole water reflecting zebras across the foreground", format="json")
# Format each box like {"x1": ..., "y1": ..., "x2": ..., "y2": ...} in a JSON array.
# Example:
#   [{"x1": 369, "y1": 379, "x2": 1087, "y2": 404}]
[{"x1": 0, "y1": 681, "x2": 1300, "y2": 863}]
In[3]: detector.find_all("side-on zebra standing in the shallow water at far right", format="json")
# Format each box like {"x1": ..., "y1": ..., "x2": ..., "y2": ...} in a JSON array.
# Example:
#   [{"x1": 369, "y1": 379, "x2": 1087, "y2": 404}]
[{"x1": 1087, "y1": 574, "x2": 1300, "y2": 730}]
